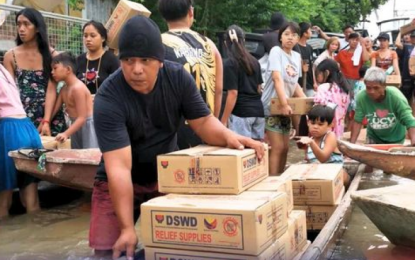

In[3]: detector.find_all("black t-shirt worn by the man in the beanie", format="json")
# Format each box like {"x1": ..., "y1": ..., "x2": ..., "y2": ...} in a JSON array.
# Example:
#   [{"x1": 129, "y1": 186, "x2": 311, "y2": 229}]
[{"x1": 94, "y1": 61, "x2": 210, "y2": 185}]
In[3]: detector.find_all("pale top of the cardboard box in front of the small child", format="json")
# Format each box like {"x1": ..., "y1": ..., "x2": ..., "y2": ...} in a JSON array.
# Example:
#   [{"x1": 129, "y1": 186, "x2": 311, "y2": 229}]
[{"x1": 281, "y1": 163, "x2": 343, "y2": 181}]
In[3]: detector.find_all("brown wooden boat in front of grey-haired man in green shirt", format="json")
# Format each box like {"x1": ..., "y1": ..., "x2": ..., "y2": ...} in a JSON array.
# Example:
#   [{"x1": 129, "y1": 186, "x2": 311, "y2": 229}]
[{"x1": 337, "y1": 140, "x2": 415, "y2": 179}]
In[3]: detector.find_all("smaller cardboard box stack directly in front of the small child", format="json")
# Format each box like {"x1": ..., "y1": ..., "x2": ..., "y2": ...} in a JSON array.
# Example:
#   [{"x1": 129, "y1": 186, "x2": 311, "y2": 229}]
[{"x1": 282, "y1": 164, "x2": 345, "y2": 230}]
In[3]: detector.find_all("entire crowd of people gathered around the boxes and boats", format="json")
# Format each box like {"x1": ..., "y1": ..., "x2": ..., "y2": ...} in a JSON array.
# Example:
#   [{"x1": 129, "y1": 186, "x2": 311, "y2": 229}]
[{"x1": 0, "y1": 0, "x2": 415, "y2": 257}]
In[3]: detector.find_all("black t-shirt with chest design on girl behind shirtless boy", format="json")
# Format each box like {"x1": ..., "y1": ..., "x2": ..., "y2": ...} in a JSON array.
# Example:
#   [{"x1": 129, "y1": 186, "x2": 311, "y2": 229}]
[{"x1": 76, "y1": 51, "x2": 120, "y2": 94}]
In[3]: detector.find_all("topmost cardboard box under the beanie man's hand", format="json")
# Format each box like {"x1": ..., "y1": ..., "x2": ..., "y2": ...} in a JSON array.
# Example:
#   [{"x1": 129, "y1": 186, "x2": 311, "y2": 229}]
[{"x1": 157, "y1": 145, "x2": 268, "y2": 194}]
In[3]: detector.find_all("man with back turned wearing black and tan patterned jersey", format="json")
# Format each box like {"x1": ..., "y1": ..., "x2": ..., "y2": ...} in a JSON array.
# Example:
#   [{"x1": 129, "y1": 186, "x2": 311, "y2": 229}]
[{"x1": 158, "y1": 0, "x2": 223, "y2": 149}]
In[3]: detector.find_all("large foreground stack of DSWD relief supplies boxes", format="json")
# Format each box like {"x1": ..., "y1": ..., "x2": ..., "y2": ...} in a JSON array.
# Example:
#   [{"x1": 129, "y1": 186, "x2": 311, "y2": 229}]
[{"x1": 141, "y1": 146, "x2": 306, "y2": 260}]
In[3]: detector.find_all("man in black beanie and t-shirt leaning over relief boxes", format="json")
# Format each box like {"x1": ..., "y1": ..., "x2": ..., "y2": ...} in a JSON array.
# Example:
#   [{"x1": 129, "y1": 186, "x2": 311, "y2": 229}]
[{"x1": 89, "y1": 16, "x2": 264, "y2": 259}]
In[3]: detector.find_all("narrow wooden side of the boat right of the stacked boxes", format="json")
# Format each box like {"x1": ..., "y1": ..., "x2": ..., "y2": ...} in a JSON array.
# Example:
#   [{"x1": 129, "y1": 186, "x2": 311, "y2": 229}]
[{"x1": 300, "y1": 164, "x2": 365, "y2": 260}]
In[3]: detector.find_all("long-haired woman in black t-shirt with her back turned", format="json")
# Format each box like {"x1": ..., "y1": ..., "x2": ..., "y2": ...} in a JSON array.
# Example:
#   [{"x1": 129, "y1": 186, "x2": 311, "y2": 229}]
[{"x1": 222, "y1": 25, "x2": 265, "y2": 140}]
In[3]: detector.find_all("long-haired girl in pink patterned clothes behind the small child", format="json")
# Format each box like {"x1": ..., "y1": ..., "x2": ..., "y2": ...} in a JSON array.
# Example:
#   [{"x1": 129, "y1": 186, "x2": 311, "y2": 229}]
[{"x1": 314, "y1": 59, "x2": 351, "y2": 138}]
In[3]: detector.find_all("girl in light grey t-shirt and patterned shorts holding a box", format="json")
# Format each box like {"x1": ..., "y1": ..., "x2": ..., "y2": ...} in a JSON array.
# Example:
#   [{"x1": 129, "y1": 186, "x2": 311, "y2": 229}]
[{"x1": 261, "y1": 22, "x2": 305, "y2": 175}]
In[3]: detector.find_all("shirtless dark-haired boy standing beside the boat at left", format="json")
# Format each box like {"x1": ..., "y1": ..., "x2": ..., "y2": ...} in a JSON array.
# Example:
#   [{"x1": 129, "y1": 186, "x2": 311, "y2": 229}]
[{"x1": 52, "y1": 53, "x2": 98, "y2": 149}]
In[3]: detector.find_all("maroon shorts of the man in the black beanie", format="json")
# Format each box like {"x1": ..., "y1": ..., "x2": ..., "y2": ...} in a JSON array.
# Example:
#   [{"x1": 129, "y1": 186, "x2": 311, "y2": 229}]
[{"x1": 89, "y1": 180, "x2": 162, "y2": 250}]
